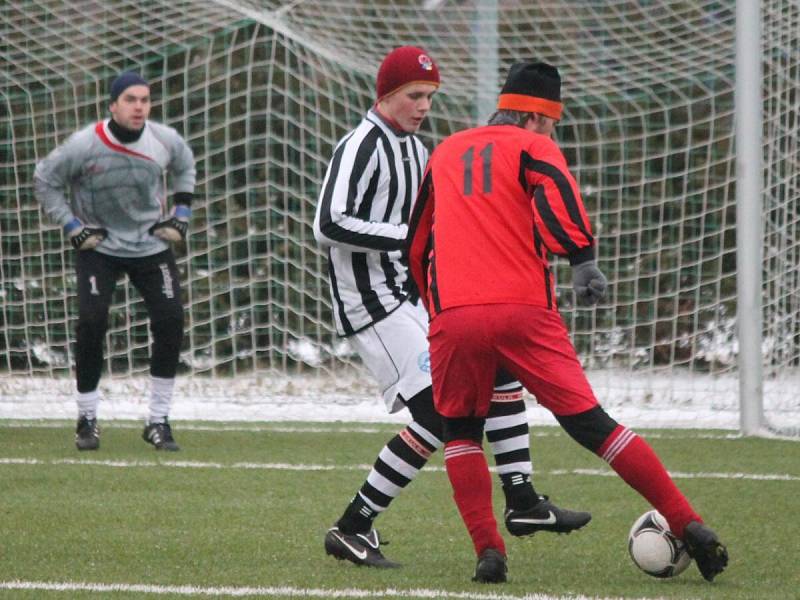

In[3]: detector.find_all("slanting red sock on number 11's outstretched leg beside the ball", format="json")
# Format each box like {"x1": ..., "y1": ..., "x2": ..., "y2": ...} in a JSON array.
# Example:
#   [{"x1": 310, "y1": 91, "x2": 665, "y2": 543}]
[{"x1": 597, "y1": 425, "x2": 702, "y2": 538}]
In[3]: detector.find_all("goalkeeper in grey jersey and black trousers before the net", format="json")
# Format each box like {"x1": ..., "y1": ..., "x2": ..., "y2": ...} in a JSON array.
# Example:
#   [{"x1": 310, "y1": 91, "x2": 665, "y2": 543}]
[{"x1": 34, "y1": 72, "x2": 195, "y2": 450}]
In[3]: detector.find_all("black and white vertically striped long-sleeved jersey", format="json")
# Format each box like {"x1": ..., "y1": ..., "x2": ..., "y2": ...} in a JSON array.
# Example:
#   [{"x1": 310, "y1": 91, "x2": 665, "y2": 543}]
[{"x1": 314, "y1": 109, "x2": 428, "y2": 336}]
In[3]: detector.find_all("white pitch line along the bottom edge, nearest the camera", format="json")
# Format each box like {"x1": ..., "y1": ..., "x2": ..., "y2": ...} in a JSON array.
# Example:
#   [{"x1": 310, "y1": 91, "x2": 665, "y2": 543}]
[{"x1": 0, "y1": 580, "x2": 676, "y2": 600}]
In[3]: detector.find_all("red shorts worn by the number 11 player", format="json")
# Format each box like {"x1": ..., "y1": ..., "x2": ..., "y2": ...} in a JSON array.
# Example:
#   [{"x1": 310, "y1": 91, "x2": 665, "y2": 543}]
[{"x1": 428, "y1": 304, "x2": 597, "y2": 417}]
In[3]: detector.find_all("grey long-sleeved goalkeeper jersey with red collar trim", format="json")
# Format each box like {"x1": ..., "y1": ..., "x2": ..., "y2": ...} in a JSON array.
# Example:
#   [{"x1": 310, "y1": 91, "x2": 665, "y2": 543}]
[{"x1": 33, "y1": 119, "x2": 195, "y2": 257}]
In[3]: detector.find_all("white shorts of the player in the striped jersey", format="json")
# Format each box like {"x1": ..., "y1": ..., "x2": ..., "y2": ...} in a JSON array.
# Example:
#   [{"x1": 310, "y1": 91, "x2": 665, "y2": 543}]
[{"x1": 349, "y1": 301, "x2": 431, "y2": 413}]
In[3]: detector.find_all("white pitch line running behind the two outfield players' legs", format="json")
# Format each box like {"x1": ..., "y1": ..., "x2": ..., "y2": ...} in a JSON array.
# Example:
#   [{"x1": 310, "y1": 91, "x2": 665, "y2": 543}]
[{"x1": 0, "y1": 457, "x2": 800, "y2": 481}]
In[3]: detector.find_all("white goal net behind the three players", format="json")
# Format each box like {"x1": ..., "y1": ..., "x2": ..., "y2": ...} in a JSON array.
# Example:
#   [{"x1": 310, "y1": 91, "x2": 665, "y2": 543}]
[{"x1": 0, "y1": 0, "x2": 800, "y2": 435}]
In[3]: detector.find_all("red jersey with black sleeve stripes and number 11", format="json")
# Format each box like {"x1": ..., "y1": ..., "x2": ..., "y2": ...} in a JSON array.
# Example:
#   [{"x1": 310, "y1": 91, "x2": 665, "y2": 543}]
[{"x1": 408, "y1": 125, "x2": 594, "y2": 317}]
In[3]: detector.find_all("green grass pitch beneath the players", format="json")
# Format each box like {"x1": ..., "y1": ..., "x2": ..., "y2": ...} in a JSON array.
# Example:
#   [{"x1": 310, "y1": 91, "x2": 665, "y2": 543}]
[{"x1": 0, "y1": 421, "x2": 800, "y2": 600}]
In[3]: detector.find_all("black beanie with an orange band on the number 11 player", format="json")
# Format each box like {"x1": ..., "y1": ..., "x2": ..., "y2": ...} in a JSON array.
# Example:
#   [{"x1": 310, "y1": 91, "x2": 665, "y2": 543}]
[{"x1": 497, "y1": 62, "x2": 562, "y2": 121}]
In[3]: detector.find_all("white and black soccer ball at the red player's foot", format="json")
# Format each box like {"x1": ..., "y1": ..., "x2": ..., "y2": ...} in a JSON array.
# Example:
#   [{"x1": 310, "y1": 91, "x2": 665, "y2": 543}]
[{"x1": 628, "y1": 510, "x2": 692, "y2": 578}]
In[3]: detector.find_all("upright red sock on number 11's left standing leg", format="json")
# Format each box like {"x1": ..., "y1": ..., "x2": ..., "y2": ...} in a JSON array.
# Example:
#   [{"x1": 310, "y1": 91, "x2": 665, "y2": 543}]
[{"x1": 444, "y1": 440, "x2": 506, "y2": 556}]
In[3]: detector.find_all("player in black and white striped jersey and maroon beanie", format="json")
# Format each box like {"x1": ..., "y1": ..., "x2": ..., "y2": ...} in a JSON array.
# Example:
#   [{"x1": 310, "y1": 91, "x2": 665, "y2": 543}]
[{"x1": 314, "y1": 46, "x2": 591, "y2": 567}]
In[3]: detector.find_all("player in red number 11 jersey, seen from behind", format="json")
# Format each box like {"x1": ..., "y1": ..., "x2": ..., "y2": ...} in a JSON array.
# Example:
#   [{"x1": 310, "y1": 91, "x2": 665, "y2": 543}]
[{"x1": 408, "y1": 63, "x2": 728, "y2": 582}]
